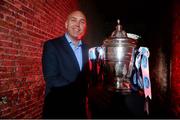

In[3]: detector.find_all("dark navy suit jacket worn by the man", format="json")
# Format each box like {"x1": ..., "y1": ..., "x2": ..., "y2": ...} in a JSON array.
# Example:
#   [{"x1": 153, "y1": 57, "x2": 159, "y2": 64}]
[{"x1": 42, "y1": 36, "x2": 88, "y2": 118}]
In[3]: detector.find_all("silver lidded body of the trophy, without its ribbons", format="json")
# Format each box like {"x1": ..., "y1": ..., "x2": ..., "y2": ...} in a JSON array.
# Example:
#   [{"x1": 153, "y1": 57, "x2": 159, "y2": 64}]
[{"x1": 102, "y1": 20, "x2": 140, "y2": 94}]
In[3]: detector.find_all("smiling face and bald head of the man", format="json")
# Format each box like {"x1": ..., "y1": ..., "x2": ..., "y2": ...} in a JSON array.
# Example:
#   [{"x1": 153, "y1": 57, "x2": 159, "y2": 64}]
[{"x1": 65, "y1": 11, "x2": 86, "y2": 40}]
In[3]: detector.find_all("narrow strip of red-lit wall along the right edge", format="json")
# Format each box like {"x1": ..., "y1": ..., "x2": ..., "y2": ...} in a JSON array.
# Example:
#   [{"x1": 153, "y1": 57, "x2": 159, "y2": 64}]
[{"x1": 171, "y1": 0, "x2": 180, "y2": 118}]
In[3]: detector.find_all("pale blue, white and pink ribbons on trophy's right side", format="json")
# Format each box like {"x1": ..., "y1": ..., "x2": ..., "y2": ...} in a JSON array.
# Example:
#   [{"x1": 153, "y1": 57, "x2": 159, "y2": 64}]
[{"x1": 133, "y1": 47, "x2": 152, "y2": 114}]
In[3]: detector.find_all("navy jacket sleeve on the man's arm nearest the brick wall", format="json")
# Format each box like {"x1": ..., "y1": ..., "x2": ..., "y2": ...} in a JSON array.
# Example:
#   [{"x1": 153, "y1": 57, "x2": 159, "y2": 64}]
[{"x1": 42, "y1": 41, "x2": 67, "y2": 95}]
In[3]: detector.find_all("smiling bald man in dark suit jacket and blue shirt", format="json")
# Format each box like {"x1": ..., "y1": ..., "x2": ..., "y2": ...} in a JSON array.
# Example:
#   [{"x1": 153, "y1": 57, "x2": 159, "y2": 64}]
[{"x1": 42, "y1": 11, "x2": 88, "y2": 118}]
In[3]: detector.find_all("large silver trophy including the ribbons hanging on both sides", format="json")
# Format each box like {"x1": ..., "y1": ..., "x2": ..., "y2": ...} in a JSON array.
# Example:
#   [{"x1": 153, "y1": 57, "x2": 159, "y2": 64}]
[{"x1": 89, "y1": 20, "x2": 152, "y2": 114}]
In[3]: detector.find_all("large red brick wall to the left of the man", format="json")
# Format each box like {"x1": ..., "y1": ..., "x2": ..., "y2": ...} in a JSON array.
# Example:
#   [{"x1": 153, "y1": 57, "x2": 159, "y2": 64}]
[{"x1": 0, "y1": 0, "x2": 79, "y2": 118}]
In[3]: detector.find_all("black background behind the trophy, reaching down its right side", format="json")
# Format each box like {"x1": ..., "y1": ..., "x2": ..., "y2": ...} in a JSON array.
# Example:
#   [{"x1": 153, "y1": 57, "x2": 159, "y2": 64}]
[{"x1": 80, "y1": 0, "x2": 173, "y2": 118}]
